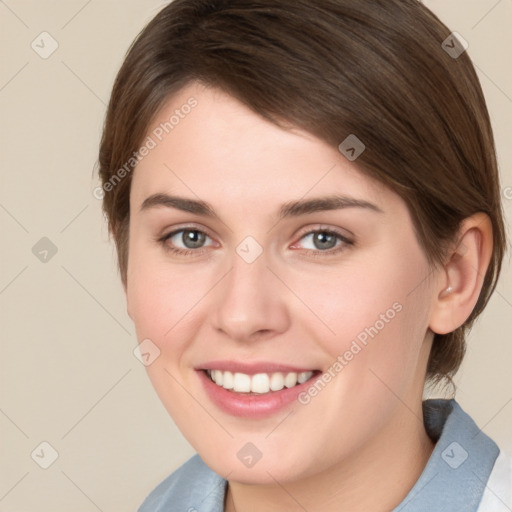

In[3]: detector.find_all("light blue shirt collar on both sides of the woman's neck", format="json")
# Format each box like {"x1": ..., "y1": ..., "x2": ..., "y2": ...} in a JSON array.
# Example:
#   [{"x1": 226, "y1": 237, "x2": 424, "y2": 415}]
[{"x1": 138, "y1": 399, "x2": 500, "y2": 512}]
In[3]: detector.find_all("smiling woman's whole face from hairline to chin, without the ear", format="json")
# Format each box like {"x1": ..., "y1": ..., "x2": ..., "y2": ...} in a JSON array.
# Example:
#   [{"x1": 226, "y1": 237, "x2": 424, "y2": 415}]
[{"x1": 126, "y1": 83, "x2": 434, "y2": 483}]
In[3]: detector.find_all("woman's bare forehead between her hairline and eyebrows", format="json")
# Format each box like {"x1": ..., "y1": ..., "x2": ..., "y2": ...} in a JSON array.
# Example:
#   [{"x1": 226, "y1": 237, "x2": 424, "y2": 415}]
[{"x1": 131, "y1": 82, "x2": 401, "y2": 217}]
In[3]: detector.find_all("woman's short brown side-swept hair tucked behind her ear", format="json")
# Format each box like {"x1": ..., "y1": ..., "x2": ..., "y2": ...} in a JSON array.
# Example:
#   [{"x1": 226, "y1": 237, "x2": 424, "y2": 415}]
[{"x1": 99, "y1": 0, "x2": 506, "y2": 381}]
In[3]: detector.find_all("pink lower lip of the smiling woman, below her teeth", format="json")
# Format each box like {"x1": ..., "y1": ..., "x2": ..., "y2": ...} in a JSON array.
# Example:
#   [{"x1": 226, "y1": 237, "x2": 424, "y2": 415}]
[{"x1": 196, "y1": 370, "x2": 316, "y2": 418}]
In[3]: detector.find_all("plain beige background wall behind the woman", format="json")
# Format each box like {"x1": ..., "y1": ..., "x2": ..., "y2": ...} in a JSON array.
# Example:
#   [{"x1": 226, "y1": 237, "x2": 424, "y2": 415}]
[{"x1": 0, "y1": 0, "x2": 512, "y2": 512}]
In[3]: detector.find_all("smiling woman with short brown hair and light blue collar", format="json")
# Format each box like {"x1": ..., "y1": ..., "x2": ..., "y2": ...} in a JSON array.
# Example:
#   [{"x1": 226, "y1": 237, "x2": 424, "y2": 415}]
[{"x1": 99, "y1": 0, "x2": 512, "y2": 512}]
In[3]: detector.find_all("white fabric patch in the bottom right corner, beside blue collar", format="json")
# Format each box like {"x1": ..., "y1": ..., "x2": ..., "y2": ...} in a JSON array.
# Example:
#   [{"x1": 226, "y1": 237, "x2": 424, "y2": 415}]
[{"x1": 477, "y1": 451, "x2": 512, "y2": 512}]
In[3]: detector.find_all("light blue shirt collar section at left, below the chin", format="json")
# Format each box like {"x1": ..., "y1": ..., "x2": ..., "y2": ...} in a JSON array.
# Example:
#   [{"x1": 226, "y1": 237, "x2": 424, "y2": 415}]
[{"x1": 138, "y1": 455, "x2": 226, "y2": 512}]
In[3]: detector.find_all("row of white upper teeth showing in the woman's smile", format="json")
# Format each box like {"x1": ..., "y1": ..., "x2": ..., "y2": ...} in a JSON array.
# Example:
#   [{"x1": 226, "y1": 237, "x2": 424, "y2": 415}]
[{"x1": 207, "y1": 370, "x2": 313, "y2": 394}]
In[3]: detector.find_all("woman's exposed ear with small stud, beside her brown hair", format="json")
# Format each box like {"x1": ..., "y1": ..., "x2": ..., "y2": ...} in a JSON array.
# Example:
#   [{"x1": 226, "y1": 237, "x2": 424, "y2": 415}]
[{"x1": 429, "y1": 212, "x2": 493, "y2": 334}]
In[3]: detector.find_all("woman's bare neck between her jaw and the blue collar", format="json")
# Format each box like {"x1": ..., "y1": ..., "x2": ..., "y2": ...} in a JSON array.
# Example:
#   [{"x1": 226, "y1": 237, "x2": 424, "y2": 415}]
[{"x1": 225, "y1": 401, "x2": 434, "y2": 512}]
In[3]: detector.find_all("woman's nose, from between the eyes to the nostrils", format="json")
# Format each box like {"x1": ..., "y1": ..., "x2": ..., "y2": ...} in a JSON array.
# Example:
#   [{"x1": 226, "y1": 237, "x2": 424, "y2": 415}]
[{"x1": 212, "y1": 246, "x2": 290, "y2": 342}]
